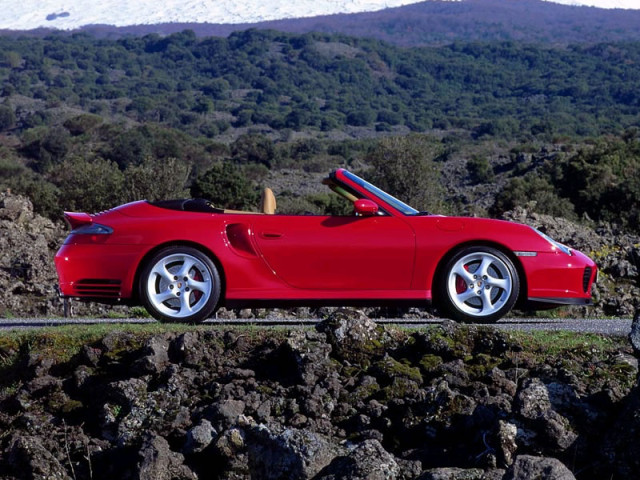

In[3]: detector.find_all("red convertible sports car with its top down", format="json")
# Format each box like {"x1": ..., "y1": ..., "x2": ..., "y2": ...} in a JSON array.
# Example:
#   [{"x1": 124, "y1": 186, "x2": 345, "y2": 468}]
[{"x1": 55, "y1": 169, "x2": 597, "y2": 322}]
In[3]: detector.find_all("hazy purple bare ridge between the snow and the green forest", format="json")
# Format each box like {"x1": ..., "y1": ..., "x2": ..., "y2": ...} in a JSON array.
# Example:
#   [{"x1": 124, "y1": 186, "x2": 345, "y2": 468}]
[{"x1": 21, "y1": 0, "x2": 640, "y2": 46}]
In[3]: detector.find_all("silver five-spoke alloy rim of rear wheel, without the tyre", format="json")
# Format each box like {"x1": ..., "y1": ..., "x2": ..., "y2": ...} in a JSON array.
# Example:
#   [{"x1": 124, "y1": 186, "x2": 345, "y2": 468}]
[{"x1": 145, "y1": 253, "x2": 214, "y2": 319}]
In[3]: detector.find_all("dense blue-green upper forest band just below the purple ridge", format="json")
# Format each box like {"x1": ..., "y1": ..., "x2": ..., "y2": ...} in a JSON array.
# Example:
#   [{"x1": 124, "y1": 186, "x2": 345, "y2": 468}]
[{"x1": 0, "y1": 30, "x2": 640, "y2": 136}]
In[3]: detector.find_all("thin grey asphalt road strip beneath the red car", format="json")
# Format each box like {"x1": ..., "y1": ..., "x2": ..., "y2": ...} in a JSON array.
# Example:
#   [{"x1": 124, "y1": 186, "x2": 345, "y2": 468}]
[{"x1": 0, "y1": 318, "x2": 631, "y2": 336}]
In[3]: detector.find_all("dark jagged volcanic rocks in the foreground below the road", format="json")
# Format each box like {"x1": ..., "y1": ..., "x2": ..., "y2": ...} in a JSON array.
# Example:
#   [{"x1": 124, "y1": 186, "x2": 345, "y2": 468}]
[{"x1": 0, "y1": 310, "x2": 640, "y2": 480}]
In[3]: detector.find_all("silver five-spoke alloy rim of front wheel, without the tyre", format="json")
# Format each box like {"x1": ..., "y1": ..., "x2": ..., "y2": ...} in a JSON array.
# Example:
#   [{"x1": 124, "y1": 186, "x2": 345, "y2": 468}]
[{"x1": 446, "y1": 251, "x2": 514, "y2": 318}]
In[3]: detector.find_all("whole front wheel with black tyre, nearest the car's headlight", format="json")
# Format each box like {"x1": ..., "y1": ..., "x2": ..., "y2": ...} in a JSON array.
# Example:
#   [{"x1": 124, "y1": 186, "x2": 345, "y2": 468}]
[{"x1": 438, "y1": 246, "x2": 520, "y2": 322}]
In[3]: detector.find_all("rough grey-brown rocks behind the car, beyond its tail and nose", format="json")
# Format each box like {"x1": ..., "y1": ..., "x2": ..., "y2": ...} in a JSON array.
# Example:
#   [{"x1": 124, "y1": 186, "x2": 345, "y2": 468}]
[{"x1": 0, "y1": 193, "x2": 640, "y2": 318}]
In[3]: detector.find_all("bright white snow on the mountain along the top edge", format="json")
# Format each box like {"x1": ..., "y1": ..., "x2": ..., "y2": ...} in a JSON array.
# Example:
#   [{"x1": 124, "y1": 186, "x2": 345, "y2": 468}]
[{"x1": 0, "y1": 0, "x2": 640, "y2": 30}]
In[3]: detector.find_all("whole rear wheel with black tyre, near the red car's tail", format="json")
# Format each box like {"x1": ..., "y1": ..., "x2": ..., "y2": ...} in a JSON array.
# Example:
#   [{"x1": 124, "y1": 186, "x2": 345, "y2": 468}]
[{"x1": 139, "y1": 246, "x2": 220, "y2": 323}]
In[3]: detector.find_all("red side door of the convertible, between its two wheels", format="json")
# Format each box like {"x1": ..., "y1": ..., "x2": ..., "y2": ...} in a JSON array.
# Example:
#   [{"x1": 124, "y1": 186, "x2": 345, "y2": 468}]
[{"x1": 253, "y1": 215, "x2": 415, "y2": 290}]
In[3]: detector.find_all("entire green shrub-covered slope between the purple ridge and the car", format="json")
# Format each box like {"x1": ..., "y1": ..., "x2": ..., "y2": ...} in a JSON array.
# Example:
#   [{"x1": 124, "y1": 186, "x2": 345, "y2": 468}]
[{"x1": 0, "y1": 30, "x2": 640, "y2": 229}]
